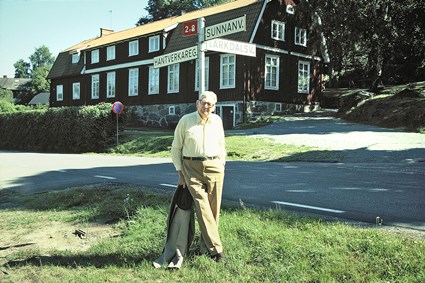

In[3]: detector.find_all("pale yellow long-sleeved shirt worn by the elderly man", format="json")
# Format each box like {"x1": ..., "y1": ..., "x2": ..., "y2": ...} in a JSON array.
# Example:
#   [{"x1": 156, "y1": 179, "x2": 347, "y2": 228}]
[{"x1": 171, "y1": 111, "x2": 226, "y2": 170}]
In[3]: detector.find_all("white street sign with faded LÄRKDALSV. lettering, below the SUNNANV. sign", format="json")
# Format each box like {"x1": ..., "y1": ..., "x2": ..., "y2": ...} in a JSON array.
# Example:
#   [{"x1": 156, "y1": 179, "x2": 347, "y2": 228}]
[{"x1": 205, "y1": 38, "x2": 257, "y2": 57}]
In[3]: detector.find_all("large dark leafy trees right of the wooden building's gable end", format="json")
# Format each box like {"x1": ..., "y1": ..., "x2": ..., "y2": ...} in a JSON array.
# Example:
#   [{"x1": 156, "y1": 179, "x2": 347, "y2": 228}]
[{"x1": 304, "y1": 0, "x2": 425, "y2": 86}]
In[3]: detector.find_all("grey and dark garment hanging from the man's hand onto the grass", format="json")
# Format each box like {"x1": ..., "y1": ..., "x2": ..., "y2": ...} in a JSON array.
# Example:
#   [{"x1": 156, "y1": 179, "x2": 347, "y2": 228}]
[{"x1": 153, "y1": 186, "x2": 195, "y2": 269}]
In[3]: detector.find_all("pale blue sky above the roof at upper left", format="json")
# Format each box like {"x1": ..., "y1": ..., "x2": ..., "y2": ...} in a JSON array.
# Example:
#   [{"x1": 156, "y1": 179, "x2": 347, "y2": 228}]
[{"x1": 0, "y1": 0, "x2": 148, "y2": 78}]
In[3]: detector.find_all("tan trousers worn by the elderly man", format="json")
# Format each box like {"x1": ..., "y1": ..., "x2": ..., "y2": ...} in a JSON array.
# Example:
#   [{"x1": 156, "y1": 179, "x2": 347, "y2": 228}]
[{"x1": 182, "y1": 159, "x2": 224, "y2": 255}]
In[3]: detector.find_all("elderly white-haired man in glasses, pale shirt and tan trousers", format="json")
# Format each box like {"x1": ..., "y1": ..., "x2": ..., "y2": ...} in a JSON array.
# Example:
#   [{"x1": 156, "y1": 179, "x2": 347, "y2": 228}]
[{"x1": 171, "y1": 91, "x2": 226, "y2": 261}]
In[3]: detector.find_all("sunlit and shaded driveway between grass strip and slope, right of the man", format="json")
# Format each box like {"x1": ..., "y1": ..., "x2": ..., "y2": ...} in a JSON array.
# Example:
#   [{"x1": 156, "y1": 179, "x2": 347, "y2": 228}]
[{"x1": 227, "y1": 111, "x2": 425, "y2": 163}]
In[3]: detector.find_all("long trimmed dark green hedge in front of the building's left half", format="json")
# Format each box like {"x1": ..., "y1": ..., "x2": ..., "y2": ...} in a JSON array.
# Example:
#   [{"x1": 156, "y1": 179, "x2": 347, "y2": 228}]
[{"x1": 0, "y1": 103, "x2": 116, "y2": 153}]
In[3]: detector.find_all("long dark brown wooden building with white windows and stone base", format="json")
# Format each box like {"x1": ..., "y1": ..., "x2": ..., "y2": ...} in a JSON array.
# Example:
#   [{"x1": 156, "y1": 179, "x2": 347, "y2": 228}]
[{"x1": 48, "y1": 0, "x2": 324, "y2": 128}]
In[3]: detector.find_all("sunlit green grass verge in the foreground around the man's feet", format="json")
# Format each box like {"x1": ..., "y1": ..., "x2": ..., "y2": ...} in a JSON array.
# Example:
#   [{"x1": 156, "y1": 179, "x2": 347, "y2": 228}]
[{"x1": 0, "y1": 185, "x2": 425, "y2": 282}]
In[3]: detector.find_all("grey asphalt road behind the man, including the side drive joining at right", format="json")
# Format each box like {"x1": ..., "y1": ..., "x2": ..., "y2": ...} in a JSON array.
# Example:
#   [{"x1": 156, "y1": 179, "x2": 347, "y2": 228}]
[{"x1": 0, "y1": 112, "x2": 425, "y2": 231}]
